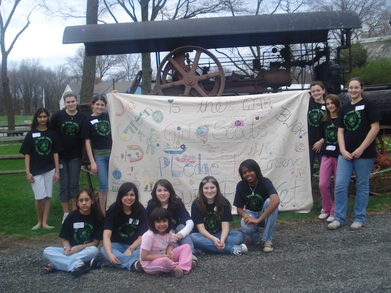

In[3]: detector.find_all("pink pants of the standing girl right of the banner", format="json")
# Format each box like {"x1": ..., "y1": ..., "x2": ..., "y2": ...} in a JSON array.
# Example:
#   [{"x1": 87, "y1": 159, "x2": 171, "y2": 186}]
[{"x1": 319, "y1": 156, "x2": 338, "y2": 217}]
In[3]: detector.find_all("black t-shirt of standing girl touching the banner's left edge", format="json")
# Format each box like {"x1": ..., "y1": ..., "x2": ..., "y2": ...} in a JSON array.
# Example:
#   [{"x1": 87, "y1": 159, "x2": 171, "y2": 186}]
[{"x1": 82, "y1": 113, "x2": 112, "y2": 150}]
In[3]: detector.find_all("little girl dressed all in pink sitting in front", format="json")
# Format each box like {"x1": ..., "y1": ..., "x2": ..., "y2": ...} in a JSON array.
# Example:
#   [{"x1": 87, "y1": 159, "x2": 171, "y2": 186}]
[{"x1": 140, "y1": 207, "x2": 192, "y2": 278}]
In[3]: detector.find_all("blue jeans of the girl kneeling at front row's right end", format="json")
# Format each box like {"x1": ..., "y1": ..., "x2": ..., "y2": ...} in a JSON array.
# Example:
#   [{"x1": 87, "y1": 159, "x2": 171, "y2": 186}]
[{"x1": 240, "y1": 198, "x2": 278, "y2": 243}]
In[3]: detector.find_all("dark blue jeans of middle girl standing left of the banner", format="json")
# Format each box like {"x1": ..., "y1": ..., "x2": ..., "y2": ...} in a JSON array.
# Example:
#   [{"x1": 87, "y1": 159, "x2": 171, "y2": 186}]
[{"x1": 58, "y1": 158, "x2": 81, "y2": 202}]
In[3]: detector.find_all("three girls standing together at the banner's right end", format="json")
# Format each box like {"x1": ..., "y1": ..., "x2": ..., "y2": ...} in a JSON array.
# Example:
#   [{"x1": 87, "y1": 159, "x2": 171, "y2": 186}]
[{"x1": 308, "y1": 78, "x2": 381, "y2": 230}]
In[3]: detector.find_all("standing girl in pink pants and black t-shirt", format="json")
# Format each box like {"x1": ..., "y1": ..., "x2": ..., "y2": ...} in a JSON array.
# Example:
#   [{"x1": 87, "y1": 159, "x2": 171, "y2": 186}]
[{"x1": 319, "y1": 95, "x2": 341, "y2": 222}]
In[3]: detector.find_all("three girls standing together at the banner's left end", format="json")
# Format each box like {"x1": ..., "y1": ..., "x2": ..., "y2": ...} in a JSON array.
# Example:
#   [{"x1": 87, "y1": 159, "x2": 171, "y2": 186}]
[{"x1": 20, "y1": 92, "x2": 112, "y2": 230}]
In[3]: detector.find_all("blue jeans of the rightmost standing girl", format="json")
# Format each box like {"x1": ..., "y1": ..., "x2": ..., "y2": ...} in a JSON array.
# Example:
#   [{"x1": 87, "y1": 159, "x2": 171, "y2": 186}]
[{"x1": 334, "y1": 155, "x2": 375, "y2": 224}]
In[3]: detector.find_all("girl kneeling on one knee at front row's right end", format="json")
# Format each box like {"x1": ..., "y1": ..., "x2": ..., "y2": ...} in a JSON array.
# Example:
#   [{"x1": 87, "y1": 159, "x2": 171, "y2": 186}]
[{"x1": 234, "y1": 159, "x2": 280, "y2": 252}]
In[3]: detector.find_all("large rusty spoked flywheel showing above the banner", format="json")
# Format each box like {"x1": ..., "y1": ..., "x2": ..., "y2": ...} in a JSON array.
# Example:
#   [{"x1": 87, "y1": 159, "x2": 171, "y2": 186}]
[{"x1": 156, "y1": 46, "x2": 225, "y2": 97}]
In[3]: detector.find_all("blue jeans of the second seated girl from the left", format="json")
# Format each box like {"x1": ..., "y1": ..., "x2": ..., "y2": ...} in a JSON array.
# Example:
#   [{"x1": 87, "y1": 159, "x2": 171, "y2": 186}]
[{"x1": 100, "y1": 242, "x2": 140, "y2": 271}]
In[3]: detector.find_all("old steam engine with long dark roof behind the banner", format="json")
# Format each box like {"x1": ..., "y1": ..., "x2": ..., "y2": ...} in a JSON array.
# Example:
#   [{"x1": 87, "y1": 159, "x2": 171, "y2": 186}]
[{"x1": 63, "y1": 11, "x2": 391, "y2": 193}]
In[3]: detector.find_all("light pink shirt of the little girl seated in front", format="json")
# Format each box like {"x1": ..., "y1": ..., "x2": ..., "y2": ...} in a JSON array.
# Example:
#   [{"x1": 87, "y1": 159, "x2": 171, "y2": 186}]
[{"x1": 140, "y1": 230, "x2": 172, "y2": 266}]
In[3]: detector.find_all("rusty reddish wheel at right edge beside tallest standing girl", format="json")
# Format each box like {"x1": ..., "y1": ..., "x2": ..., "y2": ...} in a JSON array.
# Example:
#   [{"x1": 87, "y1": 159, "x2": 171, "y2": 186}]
[{"x1": 369, "y1": 125, "x2": 391, "y2": 195}]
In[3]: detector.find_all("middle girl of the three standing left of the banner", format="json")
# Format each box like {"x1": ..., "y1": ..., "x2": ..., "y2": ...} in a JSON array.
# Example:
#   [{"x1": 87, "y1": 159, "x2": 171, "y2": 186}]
[{"x1": 50, "y1": 92, "x2": 85, "y2": 222}]
